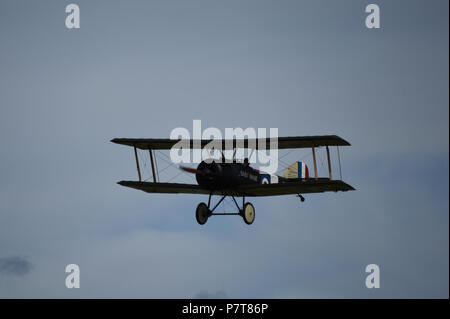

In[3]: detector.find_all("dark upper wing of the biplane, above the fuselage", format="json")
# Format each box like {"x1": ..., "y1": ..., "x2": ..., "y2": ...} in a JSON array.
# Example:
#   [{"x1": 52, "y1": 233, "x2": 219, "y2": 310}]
[{"x1": 111, "y1": 135, "x2": 350, "y2": 150}]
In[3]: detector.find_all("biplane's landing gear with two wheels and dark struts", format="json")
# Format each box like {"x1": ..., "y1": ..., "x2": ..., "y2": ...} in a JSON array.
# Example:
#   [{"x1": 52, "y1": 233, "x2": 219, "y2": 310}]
[{"x1": 195, "y1": 194, "x2": 255, "y2": 225}]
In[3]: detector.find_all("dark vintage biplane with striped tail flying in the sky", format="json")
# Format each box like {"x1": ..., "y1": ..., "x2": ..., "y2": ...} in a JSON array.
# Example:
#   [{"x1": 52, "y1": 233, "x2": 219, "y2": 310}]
[{"x1": 111, "y1": 135, "x2": 354, "y2": 225}]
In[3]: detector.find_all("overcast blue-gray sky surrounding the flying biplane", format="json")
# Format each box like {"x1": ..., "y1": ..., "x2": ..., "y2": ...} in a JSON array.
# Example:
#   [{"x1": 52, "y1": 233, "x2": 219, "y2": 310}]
[{"x1": 0, "y1": 0, "x2": 449, "y2": 298}]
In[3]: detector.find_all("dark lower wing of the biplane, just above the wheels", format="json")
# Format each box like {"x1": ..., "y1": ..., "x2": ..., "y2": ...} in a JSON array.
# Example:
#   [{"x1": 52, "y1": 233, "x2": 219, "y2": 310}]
[{"x1": 118, "y1": 178, "x2": 354, "y2": 197}]
